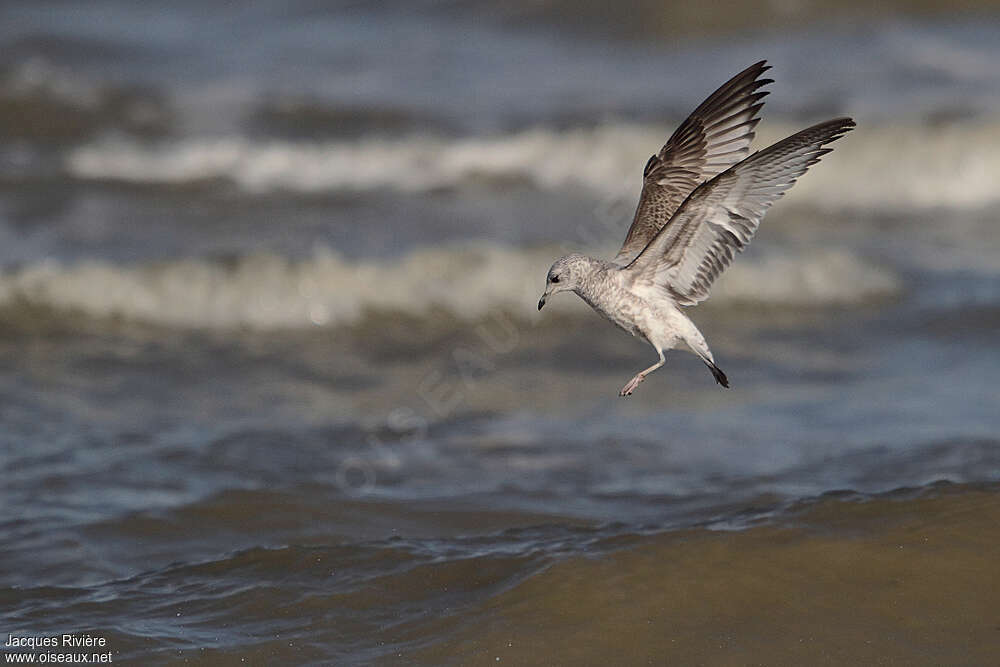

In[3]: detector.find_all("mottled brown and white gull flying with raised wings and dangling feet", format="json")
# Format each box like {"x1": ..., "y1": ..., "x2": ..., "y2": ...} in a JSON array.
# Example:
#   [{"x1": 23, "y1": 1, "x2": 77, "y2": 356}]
[{"x1": 538, "y1": 60, "x2": 854, "y2": 396}]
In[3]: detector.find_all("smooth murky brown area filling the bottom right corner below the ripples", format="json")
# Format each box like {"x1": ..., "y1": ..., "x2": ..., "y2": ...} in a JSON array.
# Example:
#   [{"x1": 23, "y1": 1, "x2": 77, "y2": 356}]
[{"x1": 405, "y1": 486, "x2": 1000, "y2": 665}]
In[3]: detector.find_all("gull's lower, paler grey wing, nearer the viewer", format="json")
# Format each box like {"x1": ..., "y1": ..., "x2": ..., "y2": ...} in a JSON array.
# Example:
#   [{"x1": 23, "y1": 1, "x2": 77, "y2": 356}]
[{"x1": 623, "y1": 118, "x2": 854, "y2": 306}]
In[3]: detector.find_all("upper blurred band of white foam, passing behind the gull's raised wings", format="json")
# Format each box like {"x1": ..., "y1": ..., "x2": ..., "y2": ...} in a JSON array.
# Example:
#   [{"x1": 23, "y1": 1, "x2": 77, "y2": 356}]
[{"x1": 66, "y1": 119, "x2": 1000, "y2": 211}]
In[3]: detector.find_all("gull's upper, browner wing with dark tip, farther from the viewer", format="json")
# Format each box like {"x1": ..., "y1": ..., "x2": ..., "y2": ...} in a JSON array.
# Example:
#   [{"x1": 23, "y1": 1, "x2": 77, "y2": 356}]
[{"x1": 613, "y1": 60, "x2": 772, "y2": 266}]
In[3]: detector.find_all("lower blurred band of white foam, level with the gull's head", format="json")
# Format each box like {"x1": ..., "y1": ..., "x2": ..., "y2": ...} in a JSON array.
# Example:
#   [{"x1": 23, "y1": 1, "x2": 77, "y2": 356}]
[{"x1": 0, "y1": 244, "x2": 898, "y2": 329}]
